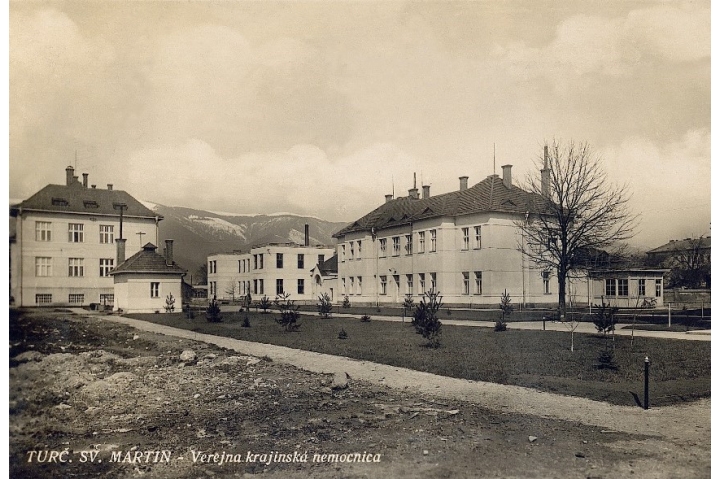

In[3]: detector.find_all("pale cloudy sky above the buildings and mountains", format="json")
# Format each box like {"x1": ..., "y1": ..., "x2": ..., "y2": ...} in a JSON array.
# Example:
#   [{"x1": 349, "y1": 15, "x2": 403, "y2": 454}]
[{"x1": 9, "y1": 0, "x2": 710, "y2": 249}]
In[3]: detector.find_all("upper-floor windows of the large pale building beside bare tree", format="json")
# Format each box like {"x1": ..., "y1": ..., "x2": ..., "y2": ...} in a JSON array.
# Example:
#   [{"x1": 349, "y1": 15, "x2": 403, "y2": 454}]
[{"x1": 340, "y1": 226, "x2": 482, "y2": 261}]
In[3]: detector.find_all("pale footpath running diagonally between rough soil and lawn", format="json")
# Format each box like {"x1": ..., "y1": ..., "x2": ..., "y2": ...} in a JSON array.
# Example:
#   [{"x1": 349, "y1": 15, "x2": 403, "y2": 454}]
[{"x1": 72, "y1": 308, "x2": 710, "y2": 444}]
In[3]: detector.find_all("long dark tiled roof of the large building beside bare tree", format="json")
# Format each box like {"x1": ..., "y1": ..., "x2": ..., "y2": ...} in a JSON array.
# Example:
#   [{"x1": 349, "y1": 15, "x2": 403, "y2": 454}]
[{"x1": 333, "y1": 175, "x2": 545, "y2": 238}]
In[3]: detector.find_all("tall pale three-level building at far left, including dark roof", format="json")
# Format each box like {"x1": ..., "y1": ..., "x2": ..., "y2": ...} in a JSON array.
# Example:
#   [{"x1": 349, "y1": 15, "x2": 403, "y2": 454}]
[{"x1": 10, "y1": 166, "x2": 162, "y2": 306}]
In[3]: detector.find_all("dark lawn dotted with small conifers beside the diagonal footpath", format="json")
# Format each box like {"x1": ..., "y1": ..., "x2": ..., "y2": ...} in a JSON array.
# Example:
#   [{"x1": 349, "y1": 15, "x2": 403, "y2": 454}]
[{"x1": 130, "y1": 312, "x2": 710, "y2": 406}]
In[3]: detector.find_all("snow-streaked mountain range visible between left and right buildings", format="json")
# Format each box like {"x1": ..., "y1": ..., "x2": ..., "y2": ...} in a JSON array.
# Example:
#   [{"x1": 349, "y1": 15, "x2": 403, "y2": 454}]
[{"x1": 143, "y1": 202, "x2": 345, "y2": 281}]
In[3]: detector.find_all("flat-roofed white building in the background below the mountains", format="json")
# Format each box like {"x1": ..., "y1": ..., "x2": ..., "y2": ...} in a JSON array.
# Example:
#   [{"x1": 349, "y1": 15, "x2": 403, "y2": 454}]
[{"x1": 208, "y1": 243, "x2": 335, "y2": 302}]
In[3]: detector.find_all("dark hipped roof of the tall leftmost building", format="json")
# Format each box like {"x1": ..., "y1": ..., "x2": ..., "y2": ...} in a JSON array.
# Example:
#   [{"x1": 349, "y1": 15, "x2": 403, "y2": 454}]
[{"x1": 11, "y1": 182, "x2": 162, "y2": 218}]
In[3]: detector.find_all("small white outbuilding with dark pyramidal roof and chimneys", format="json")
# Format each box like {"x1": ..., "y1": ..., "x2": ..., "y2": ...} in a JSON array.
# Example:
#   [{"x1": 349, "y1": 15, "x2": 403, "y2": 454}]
[{"x1": 110, "y1": 240, "x2": 186, "y2": 313}]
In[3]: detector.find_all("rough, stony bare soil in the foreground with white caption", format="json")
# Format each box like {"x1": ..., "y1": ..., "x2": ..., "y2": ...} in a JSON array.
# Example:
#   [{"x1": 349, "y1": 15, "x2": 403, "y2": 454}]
[{"x1": 10, "y1": 311, "x2": 710, "y2": 478}]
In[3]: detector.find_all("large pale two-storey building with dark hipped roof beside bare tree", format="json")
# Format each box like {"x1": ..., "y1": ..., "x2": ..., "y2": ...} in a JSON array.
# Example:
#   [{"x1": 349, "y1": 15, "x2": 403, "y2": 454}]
[{"x1": 334, "y1": 165, "x2": 552, "y2": 307}]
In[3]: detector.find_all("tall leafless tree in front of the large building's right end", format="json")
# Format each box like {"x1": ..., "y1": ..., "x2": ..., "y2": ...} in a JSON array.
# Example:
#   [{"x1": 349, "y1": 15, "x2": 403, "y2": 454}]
[{"x1": 518, "y1": 141, "x2": 637, "y2": 320}]
